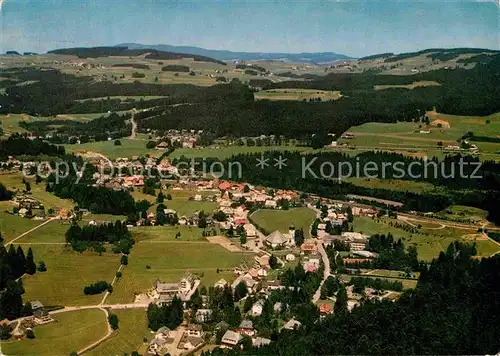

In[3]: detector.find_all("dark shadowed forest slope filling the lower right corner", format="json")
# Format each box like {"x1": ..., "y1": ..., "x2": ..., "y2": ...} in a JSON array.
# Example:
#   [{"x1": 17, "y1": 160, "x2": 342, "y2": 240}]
[{"x1": 205, "y1": 242, "x2": 500, "y2": 356}]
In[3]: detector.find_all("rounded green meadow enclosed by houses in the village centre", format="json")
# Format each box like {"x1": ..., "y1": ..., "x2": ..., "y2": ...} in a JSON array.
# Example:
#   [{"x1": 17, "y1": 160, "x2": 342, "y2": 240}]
[{"x1": 252, "y1": 208, "x2": 316, "y2": 238}]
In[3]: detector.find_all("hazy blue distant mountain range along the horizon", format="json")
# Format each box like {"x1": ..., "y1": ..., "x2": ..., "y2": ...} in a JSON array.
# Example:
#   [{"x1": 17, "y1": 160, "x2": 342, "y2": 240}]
[{"x1": 117, "y1": 43, "x2": 352, "y2": 63}]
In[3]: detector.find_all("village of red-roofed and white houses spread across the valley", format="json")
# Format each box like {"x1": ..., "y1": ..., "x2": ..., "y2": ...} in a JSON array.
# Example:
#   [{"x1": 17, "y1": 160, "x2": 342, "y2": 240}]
[{"x1": 0, "y1": 152, "x2": 404, "y2": 355}]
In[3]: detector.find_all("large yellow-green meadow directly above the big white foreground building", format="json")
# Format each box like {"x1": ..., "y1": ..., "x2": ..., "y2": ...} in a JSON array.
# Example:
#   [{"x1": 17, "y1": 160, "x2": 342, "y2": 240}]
[{"x1": 107, "y1": 241, "x2": 253, "y2": 303}]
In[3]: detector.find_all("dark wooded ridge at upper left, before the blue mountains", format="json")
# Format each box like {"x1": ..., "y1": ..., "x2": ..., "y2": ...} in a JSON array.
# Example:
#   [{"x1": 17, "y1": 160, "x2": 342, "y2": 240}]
[{"x1": 48, "y1": 47, "x2": 226, "y2": 65}]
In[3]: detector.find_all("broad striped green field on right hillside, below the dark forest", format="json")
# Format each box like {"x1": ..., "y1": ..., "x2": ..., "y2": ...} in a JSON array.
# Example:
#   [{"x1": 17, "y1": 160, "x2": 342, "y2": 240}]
[{"x1": 339, "y1": 111, "x2": 500, "y2": 160}]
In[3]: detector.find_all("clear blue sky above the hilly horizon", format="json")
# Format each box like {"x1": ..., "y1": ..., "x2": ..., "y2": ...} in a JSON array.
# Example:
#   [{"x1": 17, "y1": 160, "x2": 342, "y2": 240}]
[{"x1": 0, "y1": 0, "x2": 500, "y2": 57}]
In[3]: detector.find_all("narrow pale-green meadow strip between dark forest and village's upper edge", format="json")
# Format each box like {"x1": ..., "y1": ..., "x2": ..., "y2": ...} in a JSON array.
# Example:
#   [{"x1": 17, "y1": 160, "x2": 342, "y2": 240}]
[{"x1": 169, "y1": 146, "x2": 311, "y2": 159}]
